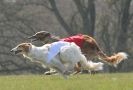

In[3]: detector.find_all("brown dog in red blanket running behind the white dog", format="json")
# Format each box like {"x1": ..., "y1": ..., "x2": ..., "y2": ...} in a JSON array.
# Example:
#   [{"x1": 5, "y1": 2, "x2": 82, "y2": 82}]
[{"x1": 29, "y1": 31, "x2": 128, "y2": 66}]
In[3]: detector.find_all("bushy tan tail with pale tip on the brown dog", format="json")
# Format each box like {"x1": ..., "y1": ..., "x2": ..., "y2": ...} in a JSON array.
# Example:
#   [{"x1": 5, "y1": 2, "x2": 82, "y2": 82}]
[{"x1": 98, "y1": 52, "x2": 128, "y2": 67}]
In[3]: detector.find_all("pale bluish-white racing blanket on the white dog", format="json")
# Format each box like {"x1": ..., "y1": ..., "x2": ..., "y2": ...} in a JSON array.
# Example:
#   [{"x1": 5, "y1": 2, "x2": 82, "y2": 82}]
[{"x1": 48, "y1": 41, "x2": 68, "y2": 62}]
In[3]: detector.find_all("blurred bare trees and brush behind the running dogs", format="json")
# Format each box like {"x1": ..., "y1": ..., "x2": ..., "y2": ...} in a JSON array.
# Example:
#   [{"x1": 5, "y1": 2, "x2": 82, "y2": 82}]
[{"x1": 0, "y1": 0, "x2": 133, "y2": 74}]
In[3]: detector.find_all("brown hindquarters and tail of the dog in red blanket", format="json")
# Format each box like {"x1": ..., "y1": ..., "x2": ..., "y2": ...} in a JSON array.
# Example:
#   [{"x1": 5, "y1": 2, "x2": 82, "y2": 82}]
[{"x1": 81, "y1": 35, "x2": 126, "y2": 65}]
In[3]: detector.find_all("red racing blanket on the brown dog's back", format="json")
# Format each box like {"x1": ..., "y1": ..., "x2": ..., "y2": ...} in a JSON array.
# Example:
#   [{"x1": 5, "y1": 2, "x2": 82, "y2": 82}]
[{"x1": 61, "y1": 34, "x2": 84, "y2": 48}]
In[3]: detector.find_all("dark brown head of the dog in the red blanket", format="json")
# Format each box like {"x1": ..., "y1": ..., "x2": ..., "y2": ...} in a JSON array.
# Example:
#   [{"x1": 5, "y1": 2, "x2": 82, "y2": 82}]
[{"x1": 28, "y1": 31, "x2": 51, "y2": 42}]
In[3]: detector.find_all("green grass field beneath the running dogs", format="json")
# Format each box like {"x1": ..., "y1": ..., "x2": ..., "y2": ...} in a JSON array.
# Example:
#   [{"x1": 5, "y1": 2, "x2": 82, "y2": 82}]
[{"x1": 0, "y1": 73, "x2": 133, "y2": 90}]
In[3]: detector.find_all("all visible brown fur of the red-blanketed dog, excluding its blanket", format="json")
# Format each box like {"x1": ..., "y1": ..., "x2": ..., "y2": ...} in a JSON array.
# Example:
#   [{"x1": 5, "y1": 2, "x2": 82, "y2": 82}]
[{"x1": 27, "y1": 31, "x2": 126, "y2": 71}]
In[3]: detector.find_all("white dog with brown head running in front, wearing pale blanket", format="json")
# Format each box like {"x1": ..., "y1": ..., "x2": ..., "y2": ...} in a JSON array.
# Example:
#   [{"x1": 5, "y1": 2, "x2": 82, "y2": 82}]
[{"x1": 11, "y1": 42, "x2": 103, "y2": 77}]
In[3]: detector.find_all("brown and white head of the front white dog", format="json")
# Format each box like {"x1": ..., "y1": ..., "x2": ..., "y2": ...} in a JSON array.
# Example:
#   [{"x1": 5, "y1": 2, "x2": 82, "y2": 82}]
[{"x1": 11, "y1": 43, "x2": 32, "y2": 54}]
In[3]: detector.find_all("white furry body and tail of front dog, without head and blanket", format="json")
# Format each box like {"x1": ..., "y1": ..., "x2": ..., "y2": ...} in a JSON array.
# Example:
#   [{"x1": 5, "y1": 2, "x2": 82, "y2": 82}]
[{"x1": 13, "y1": 42, "x2": 103, "y2": 76}]
